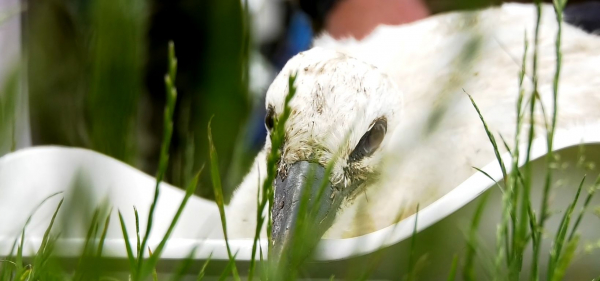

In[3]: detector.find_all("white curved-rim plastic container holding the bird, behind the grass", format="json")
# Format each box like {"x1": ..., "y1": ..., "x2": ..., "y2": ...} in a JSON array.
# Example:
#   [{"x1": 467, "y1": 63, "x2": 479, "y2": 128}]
[{"x1": 0, "y1": 125, "x2": 600, "y2": 280}]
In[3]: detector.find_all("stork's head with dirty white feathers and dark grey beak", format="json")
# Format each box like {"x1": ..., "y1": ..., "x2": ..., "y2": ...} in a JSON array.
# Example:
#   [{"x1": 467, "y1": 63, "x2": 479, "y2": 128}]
[{"x1": 265, "y1": 48, "x2": 402, "y2": 256}]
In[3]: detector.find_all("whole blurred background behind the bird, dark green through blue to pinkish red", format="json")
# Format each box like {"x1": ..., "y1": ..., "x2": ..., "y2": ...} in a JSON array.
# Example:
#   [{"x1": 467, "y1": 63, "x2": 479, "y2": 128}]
[{"x1": 22, "y1": 0, "x2": 596, "y2": 198}]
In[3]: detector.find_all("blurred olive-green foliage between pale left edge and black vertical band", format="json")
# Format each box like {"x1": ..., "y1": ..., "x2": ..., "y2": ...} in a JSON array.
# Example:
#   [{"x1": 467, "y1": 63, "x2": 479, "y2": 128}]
[{"x1": 28, "y1": 0, "x2": 147, "y2": 163}]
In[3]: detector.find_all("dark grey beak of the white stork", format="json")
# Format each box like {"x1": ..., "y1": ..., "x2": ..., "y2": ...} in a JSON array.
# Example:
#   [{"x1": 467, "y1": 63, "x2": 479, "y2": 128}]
[{"x1": 270, "y1": 161, "x2": 343, "y2": 261}]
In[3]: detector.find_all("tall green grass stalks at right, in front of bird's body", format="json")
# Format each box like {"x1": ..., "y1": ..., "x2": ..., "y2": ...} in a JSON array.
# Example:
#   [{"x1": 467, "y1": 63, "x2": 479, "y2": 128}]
[{"x1": 466, "y1": 1, "x2": 598, "y2": 280}]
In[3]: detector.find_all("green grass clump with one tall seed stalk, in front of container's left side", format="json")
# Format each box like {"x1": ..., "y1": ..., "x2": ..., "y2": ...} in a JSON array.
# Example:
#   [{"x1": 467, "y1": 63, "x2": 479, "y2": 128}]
[{"x1": 0, "y1": 42, "x2": 203, "y2": 281}]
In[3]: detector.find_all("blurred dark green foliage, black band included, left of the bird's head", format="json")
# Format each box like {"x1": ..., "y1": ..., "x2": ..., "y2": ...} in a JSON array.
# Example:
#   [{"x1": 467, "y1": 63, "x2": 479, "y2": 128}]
[{"x1": 27, "y1": 0, "x2": 253, "y2": 199}]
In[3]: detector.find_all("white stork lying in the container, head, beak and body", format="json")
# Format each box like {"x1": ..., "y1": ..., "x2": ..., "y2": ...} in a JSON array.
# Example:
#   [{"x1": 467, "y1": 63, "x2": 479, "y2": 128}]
[{"x1": 228, "y1": 4, "x2": 600, "y2": 252}]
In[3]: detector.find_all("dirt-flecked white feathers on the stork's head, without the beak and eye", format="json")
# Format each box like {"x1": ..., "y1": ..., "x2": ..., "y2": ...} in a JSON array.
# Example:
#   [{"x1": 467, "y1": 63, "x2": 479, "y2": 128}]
[{"x1": 266, "y1": 48, "x2": 402, "y2": 192}]
